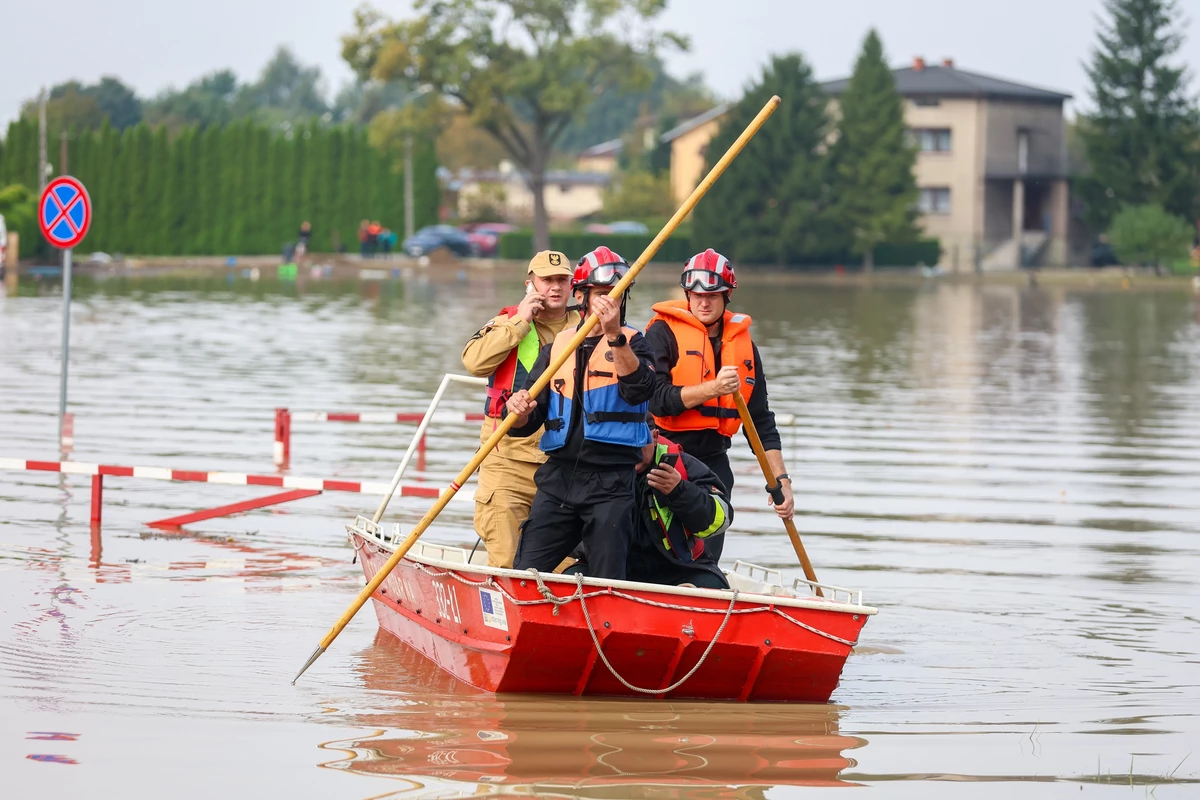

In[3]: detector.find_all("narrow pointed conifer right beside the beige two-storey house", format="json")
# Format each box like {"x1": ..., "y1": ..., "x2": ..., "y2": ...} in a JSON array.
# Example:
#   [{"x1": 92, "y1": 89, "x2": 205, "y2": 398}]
[{"x1": 832, "y1": 29, "x2": 917, "y2": 270}]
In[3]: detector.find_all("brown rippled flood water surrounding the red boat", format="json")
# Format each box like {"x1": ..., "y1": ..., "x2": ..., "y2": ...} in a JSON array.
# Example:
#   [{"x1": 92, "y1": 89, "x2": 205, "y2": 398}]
[{"x1": 0, "y1": 270, "x2": 1200, "y2": 798}]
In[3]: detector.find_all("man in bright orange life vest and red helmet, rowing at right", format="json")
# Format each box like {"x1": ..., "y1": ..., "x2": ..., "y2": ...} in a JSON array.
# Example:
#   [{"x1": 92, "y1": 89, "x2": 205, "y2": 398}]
[{"x1": 646, "y1": 248, "x2": 796, "y2": 558}]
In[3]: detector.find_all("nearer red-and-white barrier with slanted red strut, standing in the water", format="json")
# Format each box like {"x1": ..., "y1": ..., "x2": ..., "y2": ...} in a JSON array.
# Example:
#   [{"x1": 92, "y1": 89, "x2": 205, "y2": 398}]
[{"x1": 0, "y1": 458, "x2": 443, "y2": 527}]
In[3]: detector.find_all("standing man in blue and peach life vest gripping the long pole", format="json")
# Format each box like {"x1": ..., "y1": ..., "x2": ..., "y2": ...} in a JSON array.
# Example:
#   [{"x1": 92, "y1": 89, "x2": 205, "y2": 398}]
[{"x1": 508, "y1": 247, "x2": 654, "y2": 579}]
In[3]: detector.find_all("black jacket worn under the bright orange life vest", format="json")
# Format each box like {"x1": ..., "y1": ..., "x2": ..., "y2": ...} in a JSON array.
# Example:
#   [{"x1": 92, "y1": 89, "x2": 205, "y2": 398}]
[{"x1": 646, "y1": 320, "x2": 784, "y2": 458}]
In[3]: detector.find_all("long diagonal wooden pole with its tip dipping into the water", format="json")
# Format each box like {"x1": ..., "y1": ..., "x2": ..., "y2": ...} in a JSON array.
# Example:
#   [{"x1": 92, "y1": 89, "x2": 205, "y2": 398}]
[{"x1": 285, "y1": 96, "x2": 780, "y2": 684}]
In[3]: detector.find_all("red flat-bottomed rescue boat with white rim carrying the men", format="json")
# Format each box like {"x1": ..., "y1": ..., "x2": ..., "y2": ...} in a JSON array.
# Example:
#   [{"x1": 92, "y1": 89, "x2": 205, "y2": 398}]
[{"x1": 347, "y1": 517, "x2": 876, "y2": 703}]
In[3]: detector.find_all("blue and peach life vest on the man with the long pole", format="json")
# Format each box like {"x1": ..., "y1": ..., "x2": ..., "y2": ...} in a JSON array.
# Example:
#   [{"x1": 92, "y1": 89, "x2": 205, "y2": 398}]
[{"x1": 540, "y1": 327, "x2": 650, "y2": 452}]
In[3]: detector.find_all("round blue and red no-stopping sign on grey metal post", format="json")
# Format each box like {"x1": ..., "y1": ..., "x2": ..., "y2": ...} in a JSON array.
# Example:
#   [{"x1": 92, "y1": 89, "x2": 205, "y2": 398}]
[{"x1": 37, "y1": 175, "x2": 91, "y2": 450}]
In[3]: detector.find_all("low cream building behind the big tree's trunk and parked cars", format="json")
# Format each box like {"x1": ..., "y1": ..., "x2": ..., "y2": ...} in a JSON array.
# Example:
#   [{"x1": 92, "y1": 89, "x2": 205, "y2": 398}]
[{"x1": 446, "y1": 161, "x2": 612, "y2": 222}]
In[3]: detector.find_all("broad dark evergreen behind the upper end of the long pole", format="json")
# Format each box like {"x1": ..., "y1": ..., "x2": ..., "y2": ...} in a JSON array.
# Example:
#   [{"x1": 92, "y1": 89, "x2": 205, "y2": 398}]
[{"x1": 694, "y1": 54, "x2": 850, "y2": 264}]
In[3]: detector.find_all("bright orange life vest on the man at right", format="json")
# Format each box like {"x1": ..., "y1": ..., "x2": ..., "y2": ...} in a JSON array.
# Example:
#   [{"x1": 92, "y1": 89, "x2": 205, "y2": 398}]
[{"x1": 647, "y1": 300, "x2": 757, "y2": 438}]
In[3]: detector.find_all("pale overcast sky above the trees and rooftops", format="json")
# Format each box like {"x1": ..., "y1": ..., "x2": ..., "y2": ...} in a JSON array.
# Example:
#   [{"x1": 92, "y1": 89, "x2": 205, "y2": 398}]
[{"x1": 0, "y1": 0, "x2": 1200, "y2": 125}]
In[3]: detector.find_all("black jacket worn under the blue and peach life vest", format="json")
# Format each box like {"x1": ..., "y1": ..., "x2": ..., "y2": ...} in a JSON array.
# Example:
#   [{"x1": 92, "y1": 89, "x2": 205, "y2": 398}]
[{"x1": 509, "y1": 333, "x2": 654, "y2": 470}]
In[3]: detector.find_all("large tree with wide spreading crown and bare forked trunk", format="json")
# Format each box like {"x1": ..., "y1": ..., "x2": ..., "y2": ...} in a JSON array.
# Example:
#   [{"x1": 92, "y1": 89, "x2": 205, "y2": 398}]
[{"x1": 342, "y1": 0, "x2": 685, "y2": 243}]
